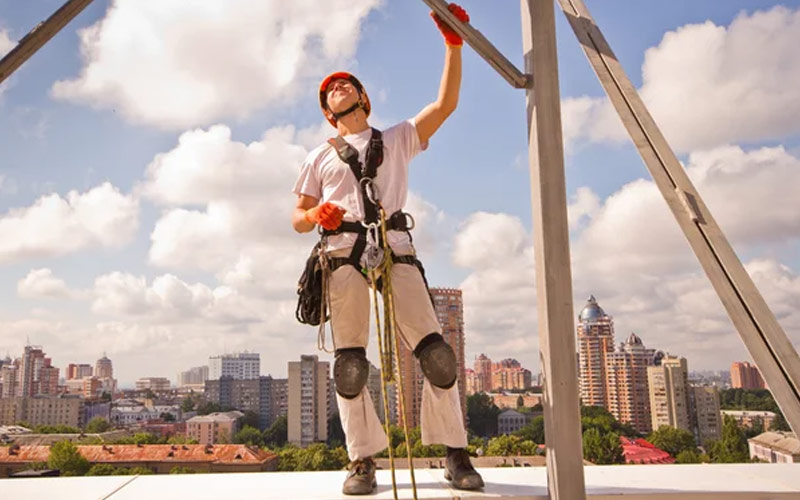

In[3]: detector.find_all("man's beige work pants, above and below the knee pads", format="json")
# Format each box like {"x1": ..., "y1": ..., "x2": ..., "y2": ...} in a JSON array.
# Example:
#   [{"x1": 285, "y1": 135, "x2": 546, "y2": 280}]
[{"x1": 329, "y1": 248, "x2": 467, "y2": 460}]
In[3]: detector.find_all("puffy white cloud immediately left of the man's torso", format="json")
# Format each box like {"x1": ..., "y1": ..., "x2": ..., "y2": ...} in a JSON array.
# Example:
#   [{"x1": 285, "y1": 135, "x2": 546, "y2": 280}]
[{"x1": 139, "y1": 125, "x2": 314, "y2": 297}]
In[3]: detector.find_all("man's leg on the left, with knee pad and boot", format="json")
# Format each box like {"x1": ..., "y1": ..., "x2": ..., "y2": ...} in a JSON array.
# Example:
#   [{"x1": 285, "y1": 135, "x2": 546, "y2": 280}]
[{"x1": 329, "y1": 249, "x2": 386, "y2": 494}]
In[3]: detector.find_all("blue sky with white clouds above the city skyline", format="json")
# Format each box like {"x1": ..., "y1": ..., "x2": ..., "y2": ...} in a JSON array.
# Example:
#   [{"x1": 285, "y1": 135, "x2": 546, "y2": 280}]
[{"x1": 0, "y1": 0, "x2": 800, "y2": 386}]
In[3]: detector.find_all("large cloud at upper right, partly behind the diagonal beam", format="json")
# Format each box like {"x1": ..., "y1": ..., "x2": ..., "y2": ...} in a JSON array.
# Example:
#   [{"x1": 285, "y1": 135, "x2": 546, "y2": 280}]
[{"x1": 563, "y1": 6, "x2": 800, "y2": 152}]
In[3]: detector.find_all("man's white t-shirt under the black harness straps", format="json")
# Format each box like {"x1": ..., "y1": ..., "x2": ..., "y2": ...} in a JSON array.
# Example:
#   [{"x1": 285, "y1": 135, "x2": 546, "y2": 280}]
[{"x1": 293, "y1": 119, "x2": 427, "y2": 254}]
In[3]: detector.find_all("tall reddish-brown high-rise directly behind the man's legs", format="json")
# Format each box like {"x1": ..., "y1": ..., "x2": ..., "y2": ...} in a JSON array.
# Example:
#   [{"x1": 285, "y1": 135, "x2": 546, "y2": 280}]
[{"x1": 395, "y1": 288, "x2": 467, "y2": 428}]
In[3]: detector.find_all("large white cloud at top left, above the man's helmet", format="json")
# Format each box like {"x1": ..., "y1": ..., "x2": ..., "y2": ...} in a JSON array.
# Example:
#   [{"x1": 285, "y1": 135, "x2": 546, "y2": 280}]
[{"x1": 52, "y1": 0, "x2": 381, "y2": 129}]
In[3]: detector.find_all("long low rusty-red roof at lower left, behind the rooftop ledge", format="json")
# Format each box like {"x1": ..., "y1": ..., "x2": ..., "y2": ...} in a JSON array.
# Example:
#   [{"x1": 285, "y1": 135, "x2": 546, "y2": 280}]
[{"x1": 0, "y1": 444, "x2": 276, "y2": 465}]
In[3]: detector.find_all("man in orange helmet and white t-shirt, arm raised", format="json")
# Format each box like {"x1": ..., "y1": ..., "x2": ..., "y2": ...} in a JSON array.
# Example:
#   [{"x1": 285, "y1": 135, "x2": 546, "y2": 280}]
[{"x1": 292, "y1": 4, "x2": 483, "y2": 494}]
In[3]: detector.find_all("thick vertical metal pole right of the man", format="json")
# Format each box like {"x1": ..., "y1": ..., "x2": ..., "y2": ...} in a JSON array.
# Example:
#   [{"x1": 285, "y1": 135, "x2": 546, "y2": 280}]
[{"x1": 521, "y1": 0, "x2": 586, "y2": 500}]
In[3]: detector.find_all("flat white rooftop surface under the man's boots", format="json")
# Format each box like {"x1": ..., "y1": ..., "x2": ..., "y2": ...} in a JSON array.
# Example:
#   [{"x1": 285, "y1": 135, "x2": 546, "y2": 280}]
[{"x1": 0, "y1": 464, "x2": 800, "y2": 500}]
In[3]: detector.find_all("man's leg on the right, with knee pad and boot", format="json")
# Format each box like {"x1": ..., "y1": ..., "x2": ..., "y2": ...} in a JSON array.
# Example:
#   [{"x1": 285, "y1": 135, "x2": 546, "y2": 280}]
[{"x1": 392, "y1": 258, "x2": 483, "y2": 489}]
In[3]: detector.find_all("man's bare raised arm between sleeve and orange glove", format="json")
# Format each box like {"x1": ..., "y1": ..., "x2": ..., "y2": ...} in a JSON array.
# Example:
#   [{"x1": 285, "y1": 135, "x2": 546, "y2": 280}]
[{"x1": 414, "y1": 44, "x2": 461, "y2": 144}]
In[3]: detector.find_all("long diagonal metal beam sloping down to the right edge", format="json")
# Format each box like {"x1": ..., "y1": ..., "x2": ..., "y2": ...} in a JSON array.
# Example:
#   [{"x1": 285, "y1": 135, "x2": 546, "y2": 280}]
[{"x1": 558, "y1": 0, "x2": 800, "y2": 432}]
